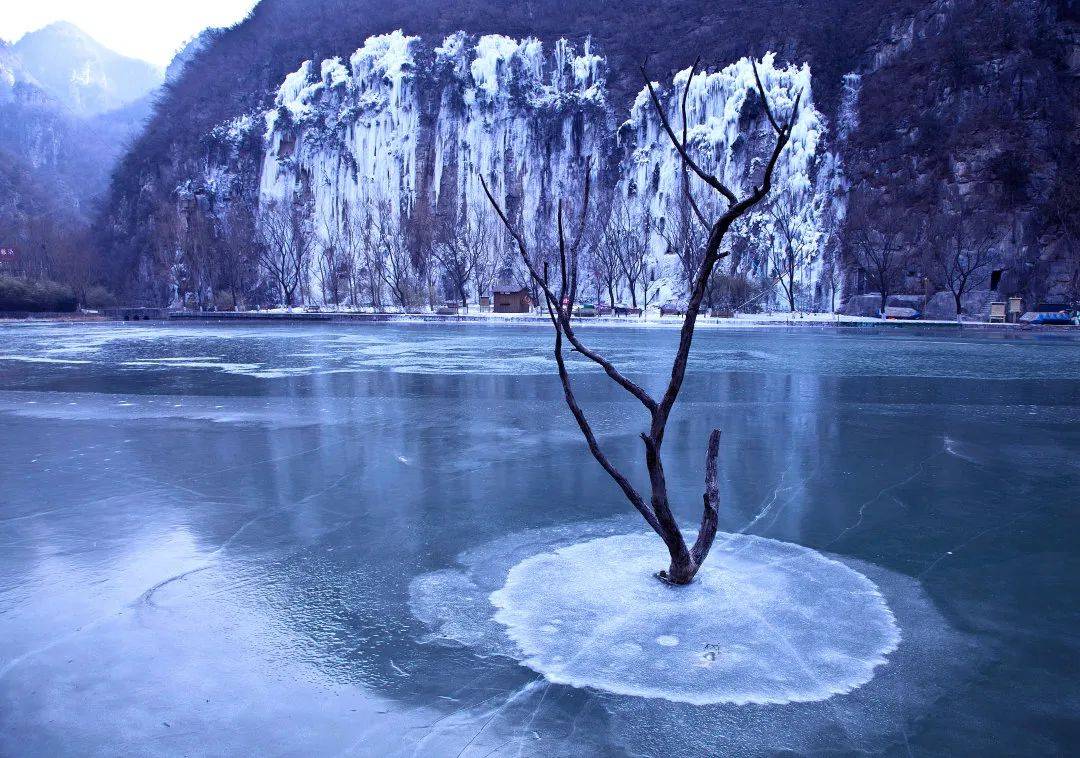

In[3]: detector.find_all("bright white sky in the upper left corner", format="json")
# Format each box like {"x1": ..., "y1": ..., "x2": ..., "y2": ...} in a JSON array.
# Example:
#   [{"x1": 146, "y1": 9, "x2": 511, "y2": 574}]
[{"x1": 0, "y1": 0, "x2": 256, "y2": 66}]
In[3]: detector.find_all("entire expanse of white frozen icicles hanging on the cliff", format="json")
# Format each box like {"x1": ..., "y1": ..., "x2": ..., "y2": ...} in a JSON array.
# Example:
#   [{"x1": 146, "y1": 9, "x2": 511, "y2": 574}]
[{"x1": 260, "y1": 31, "x2": 831, "y2": 302}]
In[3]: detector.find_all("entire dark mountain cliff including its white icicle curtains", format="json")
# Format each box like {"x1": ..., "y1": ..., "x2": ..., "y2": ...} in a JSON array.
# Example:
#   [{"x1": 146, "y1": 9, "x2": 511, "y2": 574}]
[{"x1": 100, "y1": 0, "x2": 1080, "y2": 307}]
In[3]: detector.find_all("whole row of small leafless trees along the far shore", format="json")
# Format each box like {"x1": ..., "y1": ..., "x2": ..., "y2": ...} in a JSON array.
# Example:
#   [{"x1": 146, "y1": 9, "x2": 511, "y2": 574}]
[{"x1": 166, "y1": 173, "x2": 1036, "y2": 314}]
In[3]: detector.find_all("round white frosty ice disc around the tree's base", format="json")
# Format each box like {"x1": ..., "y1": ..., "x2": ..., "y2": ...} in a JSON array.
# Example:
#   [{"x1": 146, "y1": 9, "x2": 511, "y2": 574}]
[{"x1": 490, "y1": 533, "x2": 901, "y2": 705}]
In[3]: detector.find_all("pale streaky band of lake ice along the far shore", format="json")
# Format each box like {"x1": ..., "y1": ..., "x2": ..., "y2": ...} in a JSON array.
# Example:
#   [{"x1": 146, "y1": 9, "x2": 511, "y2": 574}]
[{"x1": 0, "y1": 320, "x2": 1076, "y2": 388}]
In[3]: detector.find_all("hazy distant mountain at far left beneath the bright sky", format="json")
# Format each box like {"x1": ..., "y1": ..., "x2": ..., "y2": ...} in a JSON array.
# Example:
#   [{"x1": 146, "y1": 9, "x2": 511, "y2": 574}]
[{"x1": 0, "y1": 24, "x2": 172, "y2": 291}]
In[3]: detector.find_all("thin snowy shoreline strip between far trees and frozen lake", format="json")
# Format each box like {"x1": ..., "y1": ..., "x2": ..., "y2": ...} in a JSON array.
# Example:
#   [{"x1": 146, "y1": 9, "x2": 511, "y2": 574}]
[{"x1": 0, "y1": 311, "x2": 1080, "y2": 335}]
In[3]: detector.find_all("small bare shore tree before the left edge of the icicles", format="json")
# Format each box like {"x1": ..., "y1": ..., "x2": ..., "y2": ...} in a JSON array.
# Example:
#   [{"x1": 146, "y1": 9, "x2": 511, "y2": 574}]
[{"x1": 259, "y1": 201, "x2": 313, "y2": 308}]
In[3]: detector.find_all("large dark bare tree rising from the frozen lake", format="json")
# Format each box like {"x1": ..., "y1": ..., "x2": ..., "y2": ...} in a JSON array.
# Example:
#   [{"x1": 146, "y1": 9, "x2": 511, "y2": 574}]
[{"x1": 481, "y1": 63, "x2": 801, "y2": 585}]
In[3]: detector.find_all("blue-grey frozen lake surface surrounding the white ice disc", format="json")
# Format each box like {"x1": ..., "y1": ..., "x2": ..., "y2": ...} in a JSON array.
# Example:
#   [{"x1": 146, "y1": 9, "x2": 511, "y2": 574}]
[{"x1": 0, "y1": 324, "x2": 1080, "y2": 757}]
